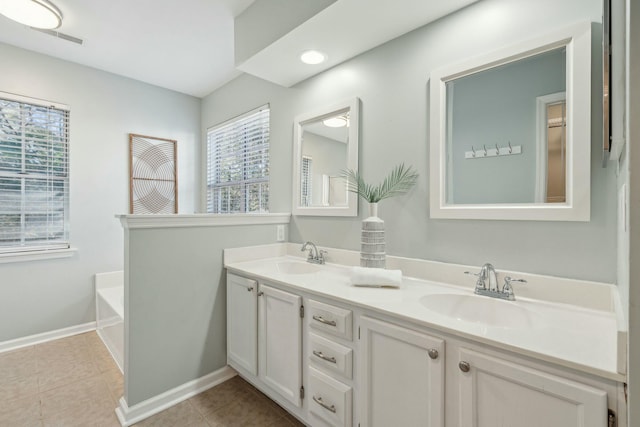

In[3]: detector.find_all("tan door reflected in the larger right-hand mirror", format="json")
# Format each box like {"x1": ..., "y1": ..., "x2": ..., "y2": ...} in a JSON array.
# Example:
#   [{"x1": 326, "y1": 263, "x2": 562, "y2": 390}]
[{"x1": 545, "y1": 101, "x2": 567, "y2": 203}]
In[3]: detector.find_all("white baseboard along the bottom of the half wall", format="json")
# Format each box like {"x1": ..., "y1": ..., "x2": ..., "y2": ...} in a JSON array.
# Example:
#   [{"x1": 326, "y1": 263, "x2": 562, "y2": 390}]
[{"x1": 116, "y1": 366, "x2": 237, "y2": 427}]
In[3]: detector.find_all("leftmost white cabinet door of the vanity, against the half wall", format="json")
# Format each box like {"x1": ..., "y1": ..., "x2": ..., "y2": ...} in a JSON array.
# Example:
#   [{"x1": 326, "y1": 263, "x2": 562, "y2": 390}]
[{"x1": 227, "y1": 273, "x2": 258, "y2": 375}]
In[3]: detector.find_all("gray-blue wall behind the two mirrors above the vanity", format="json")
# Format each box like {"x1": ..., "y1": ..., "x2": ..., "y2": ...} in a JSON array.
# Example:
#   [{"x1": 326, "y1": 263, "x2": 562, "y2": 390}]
[{"x1": 202, "y1": 0, "x2": 616, "y2": 282}]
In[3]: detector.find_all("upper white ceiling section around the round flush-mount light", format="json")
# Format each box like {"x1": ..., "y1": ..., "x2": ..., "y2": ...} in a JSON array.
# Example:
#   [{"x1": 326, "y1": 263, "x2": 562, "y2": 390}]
[{"x1": 0, "y1": 0, "x2": 253, "y2": 97}]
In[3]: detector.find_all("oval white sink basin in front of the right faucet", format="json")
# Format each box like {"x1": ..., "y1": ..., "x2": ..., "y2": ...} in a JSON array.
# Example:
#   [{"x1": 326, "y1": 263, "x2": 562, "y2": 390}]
[{"x1": 420, "y1": 294, "x2": 535, "y2": 329}]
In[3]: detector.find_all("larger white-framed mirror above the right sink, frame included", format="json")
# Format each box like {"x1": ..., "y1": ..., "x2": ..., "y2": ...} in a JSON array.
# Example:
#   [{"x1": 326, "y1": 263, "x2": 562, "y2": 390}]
[{"x1": 429, "y1": 23, "x2": 591, "y2": 221}]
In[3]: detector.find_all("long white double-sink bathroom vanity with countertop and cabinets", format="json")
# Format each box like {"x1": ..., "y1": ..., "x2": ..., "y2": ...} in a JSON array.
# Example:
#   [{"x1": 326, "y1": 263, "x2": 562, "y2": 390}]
[{"x1": 225, "y1": 244, "x2": 626, "y2": 427}]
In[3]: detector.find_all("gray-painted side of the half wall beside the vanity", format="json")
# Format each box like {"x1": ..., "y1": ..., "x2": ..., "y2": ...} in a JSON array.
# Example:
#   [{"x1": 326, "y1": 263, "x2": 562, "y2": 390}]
[{"x1": 125, "y1": 225, "x2": 284, "y2": 407}]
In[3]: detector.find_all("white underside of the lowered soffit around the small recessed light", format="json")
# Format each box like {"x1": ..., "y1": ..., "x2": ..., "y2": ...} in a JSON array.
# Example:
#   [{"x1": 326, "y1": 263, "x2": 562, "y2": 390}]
[{"x1": 238, "y1": 0, "x2": 478, "y2": 87}]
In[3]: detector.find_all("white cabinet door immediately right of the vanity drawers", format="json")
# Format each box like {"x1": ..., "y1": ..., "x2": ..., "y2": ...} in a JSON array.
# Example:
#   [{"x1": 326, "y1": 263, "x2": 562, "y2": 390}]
[{"x1": 359, "y1": 317, "x2": 445, "y2": 427}]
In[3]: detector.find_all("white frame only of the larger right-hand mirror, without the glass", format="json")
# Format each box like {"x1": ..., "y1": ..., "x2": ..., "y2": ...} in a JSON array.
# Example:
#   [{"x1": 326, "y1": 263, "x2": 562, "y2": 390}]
[{"x1": 429, "y1": 22, "x2": 591, "y2": 221}]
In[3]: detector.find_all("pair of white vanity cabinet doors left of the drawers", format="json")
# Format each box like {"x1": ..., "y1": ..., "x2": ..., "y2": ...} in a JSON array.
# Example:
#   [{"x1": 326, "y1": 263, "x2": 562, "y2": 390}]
[{"x1": 227, "y1": 273, "x2": 302, "y2": 407}]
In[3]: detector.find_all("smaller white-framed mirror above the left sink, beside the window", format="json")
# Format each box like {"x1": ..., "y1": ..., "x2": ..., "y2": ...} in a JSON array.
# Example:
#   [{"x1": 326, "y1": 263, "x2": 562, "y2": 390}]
[{"x1": 293, "y1": 98, "x2": 360, "y2": 216}]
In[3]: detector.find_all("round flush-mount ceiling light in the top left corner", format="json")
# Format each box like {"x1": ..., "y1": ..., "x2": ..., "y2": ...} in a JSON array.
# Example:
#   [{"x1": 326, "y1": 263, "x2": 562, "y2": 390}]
[{"x1": 0, "y1": 0, "x2": 62, "y2": 30}]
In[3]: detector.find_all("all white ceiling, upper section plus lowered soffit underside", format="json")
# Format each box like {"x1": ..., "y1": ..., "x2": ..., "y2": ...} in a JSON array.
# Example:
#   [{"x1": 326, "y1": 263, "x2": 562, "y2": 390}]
[{"x1": 0, "y1": 0, "x2": 477, "y2": 97}]
